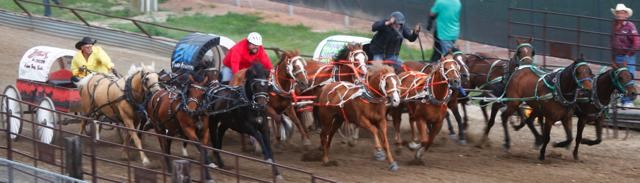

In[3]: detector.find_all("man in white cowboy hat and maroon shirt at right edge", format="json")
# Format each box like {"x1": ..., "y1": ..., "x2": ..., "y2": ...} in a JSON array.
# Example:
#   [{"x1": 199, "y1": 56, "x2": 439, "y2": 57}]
[{"x1": 611, "y1": 3, "x2": 640, "y2": 107}]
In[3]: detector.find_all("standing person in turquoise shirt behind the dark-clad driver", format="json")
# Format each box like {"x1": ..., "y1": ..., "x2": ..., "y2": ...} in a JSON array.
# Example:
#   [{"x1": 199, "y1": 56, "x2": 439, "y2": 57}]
[{"x1": 427, "y1": 0, "x2": 462, "y2": 61}]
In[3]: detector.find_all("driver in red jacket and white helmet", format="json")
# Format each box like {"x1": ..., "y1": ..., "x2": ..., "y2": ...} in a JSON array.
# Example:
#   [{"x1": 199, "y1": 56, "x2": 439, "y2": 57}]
[{"x1": 221, "y1": 32, "x2": 273, "y2": 82}]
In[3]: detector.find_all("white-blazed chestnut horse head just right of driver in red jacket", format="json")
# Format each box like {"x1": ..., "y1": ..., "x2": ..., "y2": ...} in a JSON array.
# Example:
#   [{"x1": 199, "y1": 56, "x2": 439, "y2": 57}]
[{"x1": 280, "y1": 50, "x2": 309, "y2": 89}]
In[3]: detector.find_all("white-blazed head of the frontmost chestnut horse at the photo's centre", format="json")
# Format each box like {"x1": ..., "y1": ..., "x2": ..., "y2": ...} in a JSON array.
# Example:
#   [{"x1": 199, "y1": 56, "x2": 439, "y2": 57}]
[{"x1": 366, "y1": 64, "x2": 400, "y2": 107}]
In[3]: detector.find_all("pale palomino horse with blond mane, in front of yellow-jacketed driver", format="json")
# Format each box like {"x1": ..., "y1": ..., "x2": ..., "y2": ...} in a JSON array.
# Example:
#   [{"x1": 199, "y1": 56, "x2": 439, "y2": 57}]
[{"x1": 78, "y1": 65, "x2": 160, "y2": 166}]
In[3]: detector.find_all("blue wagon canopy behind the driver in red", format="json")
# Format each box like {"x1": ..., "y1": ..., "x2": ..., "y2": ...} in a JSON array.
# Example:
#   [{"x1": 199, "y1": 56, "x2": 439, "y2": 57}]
[{"x1": 171, "y1": 33, "x2": 225, "y2": 72}]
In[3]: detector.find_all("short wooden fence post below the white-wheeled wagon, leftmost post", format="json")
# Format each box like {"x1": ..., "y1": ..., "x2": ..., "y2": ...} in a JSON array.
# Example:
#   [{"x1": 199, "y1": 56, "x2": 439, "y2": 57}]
[{"x1": 64, "y1": 136, "x2": 83, "y2": 180}]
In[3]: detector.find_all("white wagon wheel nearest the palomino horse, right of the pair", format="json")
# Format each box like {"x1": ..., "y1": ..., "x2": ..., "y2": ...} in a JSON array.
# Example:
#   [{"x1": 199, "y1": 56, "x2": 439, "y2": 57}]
[{"x1": 35, "y1": 97, "x2": 58, "y2": 144}]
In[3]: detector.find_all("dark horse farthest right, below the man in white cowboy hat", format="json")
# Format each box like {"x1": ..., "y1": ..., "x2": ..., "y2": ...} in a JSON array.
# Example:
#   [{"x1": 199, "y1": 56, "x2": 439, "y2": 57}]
[{"x1": 565, "y1": 63, "x2": 638, "y2": 160}]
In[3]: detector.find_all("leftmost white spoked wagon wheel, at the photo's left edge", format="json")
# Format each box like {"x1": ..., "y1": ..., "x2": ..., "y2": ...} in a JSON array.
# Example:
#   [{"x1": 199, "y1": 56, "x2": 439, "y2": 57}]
[{"x1": 0, "y1": 85, "x2": 22, "y2": 140}]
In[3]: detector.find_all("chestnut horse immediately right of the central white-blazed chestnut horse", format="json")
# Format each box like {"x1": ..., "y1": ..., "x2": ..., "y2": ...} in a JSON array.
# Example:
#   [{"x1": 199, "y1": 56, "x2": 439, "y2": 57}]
[{"x1": 394, "y1": 54, "x2": 461, "y2": 160}]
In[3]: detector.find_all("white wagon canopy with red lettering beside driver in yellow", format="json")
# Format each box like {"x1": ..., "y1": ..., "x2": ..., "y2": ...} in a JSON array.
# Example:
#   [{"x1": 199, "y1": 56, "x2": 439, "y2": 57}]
[{"x1": 18, "y1": 46, "x2": 76, "y2": 82}]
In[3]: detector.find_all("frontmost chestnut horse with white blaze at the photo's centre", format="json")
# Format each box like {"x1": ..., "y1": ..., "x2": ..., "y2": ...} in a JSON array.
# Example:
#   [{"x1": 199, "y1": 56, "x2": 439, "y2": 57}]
[{"x1": 314, "y1": 65, "x2": 400, "y2": 171}]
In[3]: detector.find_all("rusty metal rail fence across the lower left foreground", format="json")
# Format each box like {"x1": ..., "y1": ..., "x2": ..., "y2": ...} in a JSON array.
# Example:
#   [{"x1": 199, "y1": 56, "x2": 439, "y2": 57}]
[{"x1": 0, "y1": 94, "x2": 335, "y2": 182}]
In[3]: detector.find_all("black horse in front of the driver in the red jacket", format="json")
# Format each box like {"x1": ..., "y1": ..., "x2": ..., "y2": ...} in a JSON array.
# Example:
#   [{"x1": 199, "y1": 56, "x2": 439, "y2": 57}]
[{"x1": 206, "y1": 62, "x2": 281, "y2": 177}]
